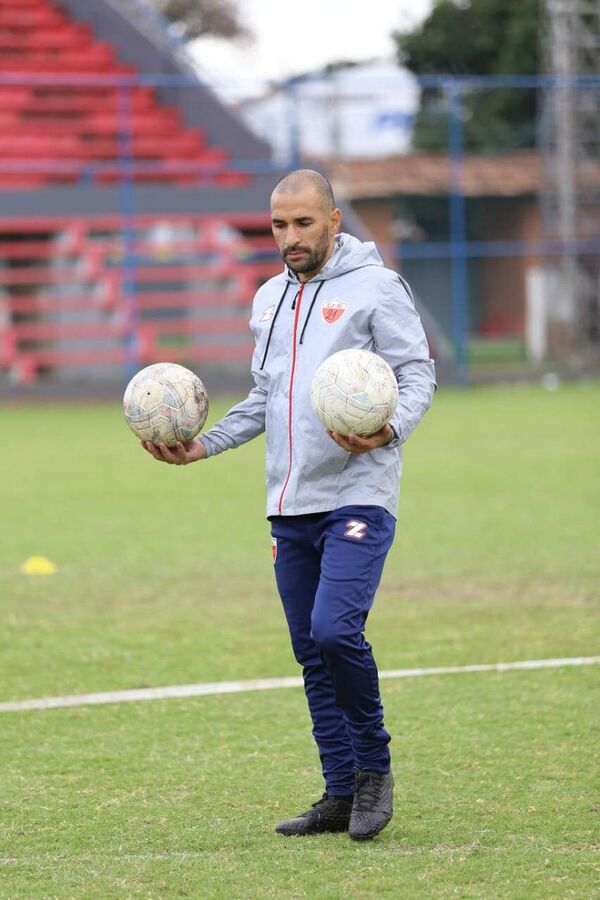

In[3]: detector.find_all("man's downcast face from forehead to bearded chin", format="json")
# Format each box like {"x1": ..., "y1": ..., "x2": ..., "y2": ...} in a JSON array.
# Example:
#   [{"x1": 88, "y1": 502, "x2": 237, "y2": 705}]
[{"x1": 271, "y1": 187, "x2": 341, "y2": 281}]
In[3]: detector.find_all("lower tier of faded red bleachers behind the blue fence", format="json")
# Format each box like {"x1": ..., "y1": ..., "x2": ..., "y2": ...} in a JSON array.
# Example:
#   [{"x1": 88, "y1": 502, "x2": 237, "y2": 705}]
[{"x1": 0, "y1": 216, "x2": 274, "y2": 383}]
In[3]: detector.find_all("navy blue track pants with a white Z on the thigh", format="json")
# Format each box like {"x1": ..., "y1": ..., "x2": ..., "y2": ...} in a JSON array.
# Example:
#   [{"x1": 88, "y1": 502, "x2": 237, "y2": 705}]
[{"x1": 271, "y1": 506, "x2": 396, "y2": 796}]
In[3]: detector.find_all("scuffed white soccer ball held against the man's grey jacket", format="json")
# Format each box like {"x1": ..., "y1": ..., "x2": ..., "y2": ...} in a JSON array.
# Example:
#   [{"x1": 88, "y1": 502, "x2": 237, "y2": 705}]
[{"x1": 310, "y1": 350, "x2": 398, "y2": 437}]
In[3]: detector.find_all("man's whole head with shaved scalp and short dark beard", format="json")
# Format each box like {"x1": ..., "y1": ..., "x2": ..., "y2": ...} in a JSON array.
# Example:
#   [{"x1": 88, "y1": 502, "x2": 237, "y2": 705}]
[{"x1": 271, "y1": 169, "x2": 342, "y2": 281}]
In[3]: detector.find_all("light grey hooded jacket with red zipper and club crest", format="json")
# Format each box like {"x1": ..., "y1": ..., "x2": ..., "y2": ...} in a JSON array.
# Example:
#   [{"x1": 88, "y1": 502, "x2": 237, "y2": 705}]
[{"x1": 201, "y1": 234, "x2": 435, "y2": 516}]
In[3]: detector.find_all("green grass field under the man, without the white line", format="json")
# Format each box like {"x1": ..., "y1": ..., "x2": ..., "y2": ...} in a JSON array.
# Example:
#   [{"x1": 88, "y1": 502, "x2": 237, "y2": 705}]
[{"x1": 0, "y1": 385, "x2": 600, "y2": 900}]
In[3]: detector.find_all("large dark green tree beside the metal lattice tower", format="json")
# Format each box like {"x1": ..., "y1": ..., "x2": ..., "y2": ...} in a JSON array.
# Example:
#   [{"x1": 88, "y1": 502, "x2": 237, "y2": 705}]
[{"x1": 394, "y1": 0, "x2": 539, "y2": 151}]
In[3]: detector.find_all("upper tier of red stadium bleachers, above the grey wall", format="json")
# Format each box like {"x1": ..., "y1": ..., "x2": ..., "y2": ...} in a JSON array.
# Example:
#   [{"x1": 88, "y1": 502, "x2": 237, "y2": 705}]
[{"x1": 0, "y1": 0, "x2": 247, "y2": 187}]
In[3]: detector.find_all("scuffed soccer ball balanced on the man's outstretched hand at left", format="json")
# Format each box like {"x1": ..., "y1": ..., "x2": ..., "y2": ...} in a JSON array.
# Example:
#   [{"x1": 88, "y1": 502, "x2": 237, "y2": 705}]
[{"x1": 123, "y1": 363, "x2": 208, "y2": 447}]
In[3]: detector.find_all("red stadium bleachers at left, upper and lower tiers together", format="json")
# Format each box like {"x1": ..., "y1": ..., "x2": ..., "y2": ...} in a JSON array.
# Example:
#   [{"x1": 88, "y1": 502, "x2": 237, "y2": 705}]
[{"x1": 0, "y1": 0, "x2": 276, "y2": 383}]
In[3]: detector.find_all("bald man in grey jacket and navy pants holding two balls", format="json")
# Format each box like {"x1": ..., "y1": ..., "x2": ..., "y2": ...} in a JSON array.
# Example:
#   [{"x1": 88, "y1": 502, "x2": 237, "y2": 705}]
[{"x1": 143, "y1": 169, "x2": 435, "y2": 840}]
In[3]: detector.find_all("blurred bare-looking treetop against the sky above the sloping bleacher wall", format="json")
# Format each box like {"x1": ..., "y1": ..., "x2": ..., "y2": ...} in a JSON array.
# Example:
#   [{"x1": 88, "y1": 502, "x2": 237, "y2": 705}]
[{"x1": 151, "y1": 0, "x2": 249, "y2": 41}]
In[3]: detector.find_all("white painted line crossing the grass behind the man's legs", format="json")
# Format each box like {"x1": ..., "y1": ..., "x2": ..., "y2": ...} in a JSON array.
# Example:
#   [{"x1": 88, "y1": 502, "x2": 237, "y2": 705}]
[{"x1": 0, "y1": 656, "x2": 600, "y2": 712}]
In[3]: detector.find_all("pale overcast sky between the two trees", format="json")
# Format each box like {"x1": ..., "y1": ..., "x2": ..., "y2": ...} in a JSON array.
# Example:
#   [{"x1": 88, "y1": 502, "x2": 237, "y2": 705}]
[{"x1": 191, "y1": 0, "x2": 432, "y2": 96}]
